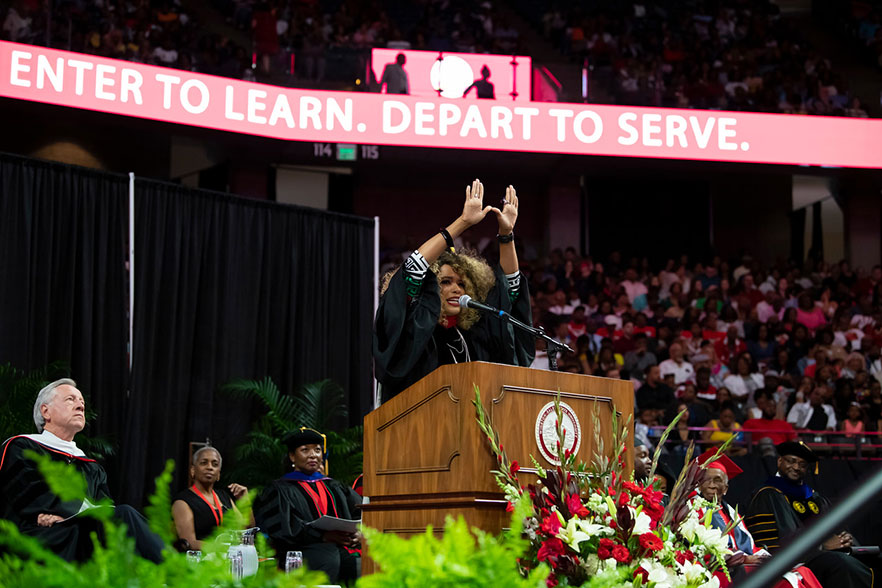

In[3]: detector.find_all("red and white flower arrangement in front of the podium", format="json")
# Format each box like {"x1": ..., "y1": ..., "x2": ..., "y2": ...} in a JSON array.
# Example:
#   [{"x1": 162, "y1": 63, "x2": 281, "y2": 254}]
[{"x1": 474, "y1": 388, "x2": 741, "y2": 588}]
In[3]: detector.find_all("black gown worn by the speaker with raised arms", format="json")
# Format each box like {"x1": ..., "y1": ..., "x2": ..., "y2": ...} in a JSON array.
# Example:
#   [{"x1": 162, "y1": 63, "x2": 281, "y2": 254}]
[{"x1": 373, "y1": 266, "x2": 536, "y2": 402}]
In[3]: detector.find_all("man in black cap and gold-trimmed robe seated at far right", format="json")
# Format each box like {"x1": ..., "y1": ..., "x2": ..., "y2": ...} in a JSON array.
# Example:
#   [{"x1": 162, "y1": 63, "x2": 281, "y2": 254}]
[{"x1": 746, "y1": 441, "x2": 873, "y2": 588}]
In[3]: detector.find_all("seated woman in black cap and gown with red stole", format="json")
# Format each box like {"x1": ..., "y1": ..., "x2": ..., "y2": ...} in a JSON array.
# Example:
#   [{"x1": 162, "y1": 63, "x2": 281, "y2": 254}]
[{"x1": 254, "y1": 428, "x2": 361, "y2": 584}]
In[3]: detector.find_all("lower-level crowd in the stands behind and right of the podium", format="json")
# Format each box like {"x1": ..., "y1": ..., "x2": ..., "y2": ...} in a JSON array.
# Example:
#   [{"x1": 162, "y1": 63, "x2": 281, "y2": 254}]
[{"x1": 522, "y1": 248, "x2": 882, "y2": 453}]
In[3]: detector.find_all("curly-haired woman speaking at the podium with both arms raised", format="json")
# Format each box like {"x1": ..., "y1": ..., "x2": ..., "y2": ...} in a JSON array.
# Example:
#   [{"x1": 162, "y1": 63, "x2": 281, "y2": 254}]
[{"x1": 373, "y1": 180, "x2": 535, "y2": 402}]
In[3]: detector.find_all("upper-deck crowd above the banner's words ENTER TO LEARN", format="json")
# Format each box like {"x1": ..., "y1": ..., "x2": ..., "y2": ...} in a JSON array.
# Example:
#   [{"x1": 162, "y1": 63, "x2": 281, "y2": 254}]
[{"x1": 0, "y1": 0, "x2": 520, "y2": 82}]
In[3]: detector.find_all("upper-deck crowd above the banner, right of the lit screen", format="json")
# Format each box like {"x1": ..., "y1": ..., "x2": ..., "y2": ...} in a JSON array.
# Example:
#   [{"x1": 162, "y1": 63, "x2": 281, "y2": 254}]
[{"x1": 542, "y1": 0, "x2": 875, "y2": 117}]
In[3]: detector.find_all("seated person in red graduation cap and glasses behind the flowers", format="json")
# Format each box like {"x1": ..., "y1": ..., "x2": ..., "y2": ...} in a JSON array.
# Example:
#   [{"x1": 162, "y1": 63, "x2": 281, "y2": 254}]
[{"x1": 696, "y1": 449, "x2": 769, "y2": 564}]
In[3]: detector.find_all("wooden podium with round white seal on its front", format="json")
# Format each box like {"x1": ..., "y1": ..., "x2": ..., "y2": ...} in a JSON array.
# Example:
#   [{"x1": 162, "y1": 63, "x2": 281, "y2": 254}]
[{"x1": 363, "y1": 362, "x2": 634, "y2": 548}]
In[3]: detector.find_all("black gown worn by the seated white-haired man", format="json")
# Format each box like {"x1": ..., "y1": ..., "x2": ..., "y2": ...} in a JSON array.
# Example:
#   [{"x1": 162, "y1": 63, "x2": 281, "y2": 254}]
[{"x1": 0, "y1": 436, "x2": 163, "y2": 562}]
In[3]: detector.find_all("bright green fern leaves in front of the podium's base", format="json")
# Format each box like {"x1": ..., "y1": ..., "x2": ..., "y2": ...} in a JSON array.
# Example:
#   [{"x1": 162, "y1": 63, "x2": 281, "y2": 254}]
[{"x1": 358, "y1": 496, "x2": 549, "y2": 588}]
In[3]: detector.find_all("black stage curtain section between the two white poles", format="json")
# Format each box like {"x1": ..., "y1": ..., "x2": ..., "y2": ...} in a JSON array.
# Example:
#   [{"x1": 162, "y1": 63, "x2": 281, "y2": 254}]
[{"x1": 122, "y1": 180, "x2": 374, "y2": 504}]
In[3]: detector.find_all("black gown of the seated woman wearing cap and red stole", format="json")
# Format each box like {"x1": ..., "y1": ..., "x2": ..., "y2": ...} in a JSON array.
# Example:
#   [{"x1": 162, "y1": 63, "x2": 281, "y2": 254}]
[{"x1": 254, "y1": 478, "x2": 361, "y2": 584}]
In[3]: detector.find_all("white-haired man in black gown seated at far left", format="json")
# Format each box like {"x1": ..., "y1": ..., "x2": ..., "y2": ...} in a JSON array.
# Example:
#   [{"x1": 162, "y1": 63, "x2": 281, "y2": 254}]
[{"x1": 0, "y1": 379, "x2": 163, "y2": 562}]
